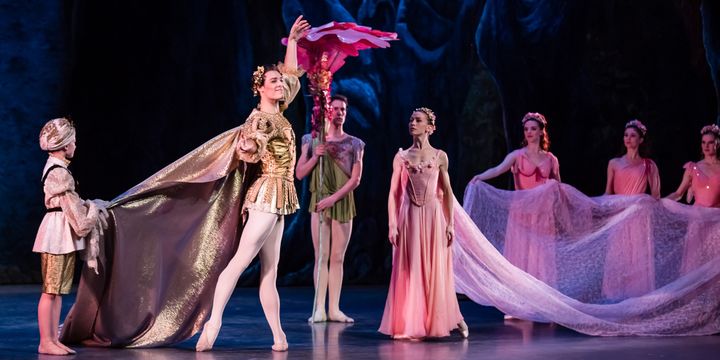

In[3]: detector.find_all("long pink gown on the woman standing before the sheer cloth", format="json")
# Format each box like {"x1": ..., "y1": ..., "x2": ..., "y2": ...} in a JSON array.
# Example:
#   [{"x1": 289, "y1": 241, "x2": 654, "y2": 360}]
[{"x1": 379, "y1": 150, "x2": 463, "y2": 338}]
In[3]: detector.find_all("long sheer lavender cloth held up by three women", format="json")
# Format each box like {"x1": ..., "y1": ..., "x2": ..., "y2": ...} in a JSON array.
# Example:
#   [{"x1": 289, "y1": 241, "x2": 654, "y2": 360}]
[{"x1": 453, "y1": 181, "x2": 720, "y2": 336}]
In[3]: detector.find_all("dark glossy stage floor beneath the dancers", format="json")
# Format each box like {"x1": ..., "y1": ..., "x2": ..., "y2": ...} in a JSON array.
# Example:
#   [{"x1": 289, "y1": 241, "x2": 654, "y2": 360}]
[{"x1": 0, "y1": 286, "x2": 720, "y2": 360}]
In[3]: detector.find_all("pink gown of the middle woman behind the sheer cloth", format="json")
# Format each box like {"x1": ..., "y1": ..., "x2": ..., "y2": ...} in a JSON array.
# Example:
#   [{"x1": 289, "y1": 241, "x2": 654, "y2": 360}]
[{"x1": 602, "y1": 159, "x2": 660, "y2": 300}]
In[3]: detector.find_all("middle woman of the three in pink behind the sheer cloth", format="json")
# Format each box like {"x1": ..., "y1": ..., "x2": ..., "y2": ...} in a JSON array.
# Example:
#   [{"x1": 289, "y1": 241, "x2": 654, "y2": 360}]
[{"x1": 602, "y1": 120, "x2": 660, "y2": 300}]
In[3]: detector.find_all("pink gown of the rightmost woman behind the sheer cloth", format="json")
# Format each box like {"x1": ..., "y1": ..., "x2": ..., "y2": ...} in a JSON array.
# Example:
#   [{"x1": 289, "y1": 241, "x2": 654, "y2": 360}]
[{"x1": 680, "y1": 162, "x2": 720, "y2": 274}]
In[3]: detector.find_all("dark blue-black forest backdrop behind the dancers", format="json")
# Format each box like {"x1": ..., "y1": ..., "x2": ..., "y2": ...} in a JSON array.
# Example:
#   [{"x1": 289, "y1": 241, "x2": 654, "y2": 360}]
[{"x1": 0, "y1": 0, "x2": 720, "y2": 285}]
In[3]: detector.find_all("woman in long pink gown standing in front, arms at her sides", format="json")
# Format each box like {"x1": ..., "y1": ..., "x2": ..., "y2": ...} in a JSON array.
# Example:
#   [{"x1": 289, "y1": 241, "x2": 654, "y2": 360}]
[{"x1": 379, "y1": 108, "x2": 468, "y2": 340}]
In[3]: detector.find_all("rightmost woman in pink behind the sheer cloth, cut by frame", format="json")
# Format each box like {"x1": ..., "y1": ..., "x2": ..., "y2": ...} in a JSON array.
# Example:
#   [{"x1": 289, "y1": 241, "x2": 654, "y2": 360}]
[{"x1": 667, "y1": 124, "x2": 720, "y2": 274}]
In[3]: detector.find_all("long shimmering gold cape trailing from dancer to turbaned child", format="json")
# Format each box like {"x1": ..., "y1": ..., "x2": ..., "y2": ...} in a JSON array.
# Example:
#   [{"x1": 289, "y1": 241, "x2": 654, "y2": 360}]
[{"x1": 61, "y1": 126, "x2": 249, "y2": 347}]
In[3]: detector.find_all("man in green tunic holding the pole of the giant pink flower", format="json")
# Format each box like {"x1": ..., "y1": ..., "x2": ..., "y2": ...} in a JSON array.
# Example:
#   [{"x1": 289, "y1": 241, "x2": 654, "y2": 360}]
[{"x1": 295, "y1": 95, "x2": 365, "y2": 323}]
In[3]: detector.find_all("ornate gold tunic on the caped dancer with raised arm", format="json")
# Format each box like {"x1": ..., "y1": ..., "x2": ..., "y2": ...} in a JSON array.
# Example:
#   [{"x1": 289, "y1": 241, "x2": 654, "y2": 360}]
[{"x1": 236, "y1": 73, "x2": 300, "y2": 215}]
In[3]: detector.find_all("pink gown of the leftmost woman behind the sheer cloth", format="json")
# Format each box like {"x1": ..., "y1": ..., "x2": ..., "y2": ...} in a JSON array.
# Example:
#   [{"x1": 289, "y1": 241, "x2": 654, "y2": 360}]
[{"x1": 503, "y1": 151, "x2": 559, "y2": 286}]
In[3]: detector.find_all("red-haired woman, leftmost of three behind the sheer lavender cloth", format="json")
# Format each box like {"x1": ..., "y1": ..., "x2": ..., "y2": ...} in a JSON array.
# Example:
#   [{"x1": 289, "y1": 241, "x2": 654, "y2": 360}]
[{"x1": 472, "y1": 113, "x2": 560, "y2": 286}]
